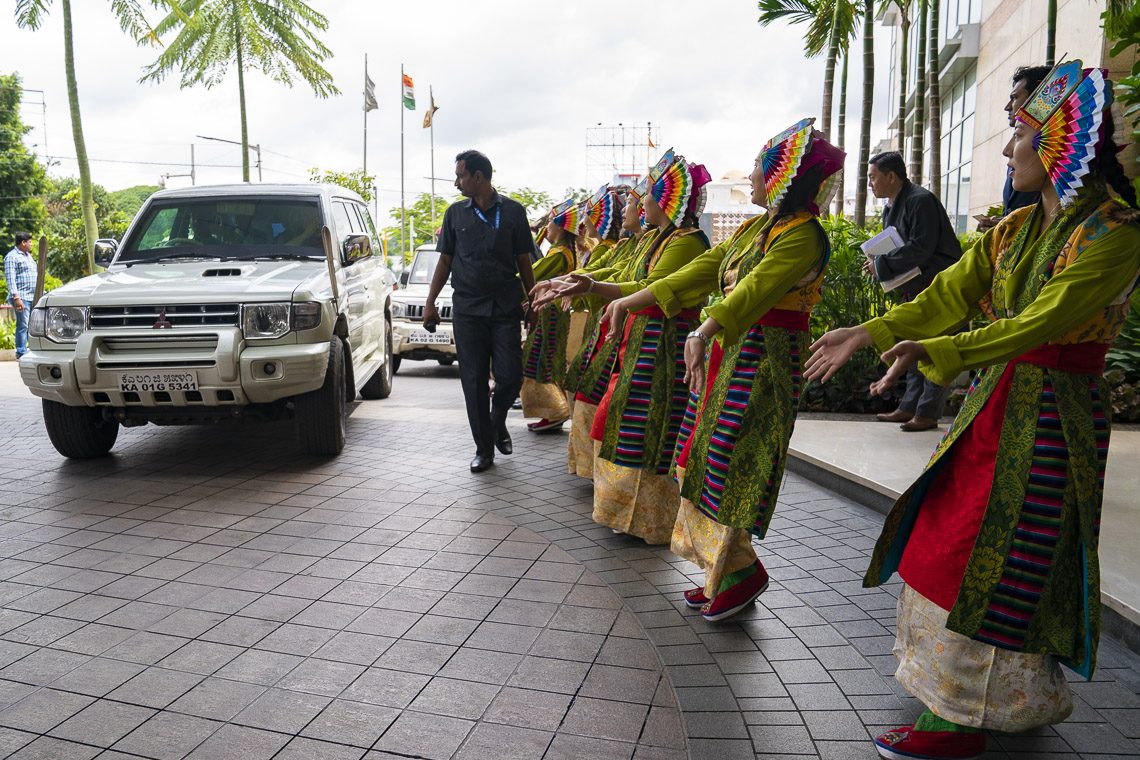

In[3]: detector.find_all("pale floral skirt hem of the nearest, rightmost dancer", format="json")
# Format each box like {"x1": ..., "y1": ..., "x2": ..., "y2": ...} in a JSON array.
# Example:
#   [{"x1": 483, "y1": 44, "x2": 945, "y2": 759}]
[{"x1": 894, "y1": 586, "x2": 1073, "y2": 733}]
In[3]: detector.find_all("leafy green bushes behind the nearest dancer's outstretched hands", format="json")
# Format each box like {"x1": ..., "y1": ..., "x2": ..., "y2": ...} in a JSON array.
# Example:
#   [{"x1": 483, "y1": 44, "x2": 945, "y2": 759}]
[{"x1": 803, "y1": 216, "x2": 897, "y2": 412}]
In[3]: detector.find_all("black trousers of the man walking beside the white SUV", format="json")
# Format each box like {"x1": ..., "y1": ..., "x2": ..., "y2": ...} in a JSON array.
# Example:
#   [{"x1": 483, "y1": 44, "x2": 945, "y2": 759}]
[{"x1": 451, "y1": 310, "x2": 522, "y2": 457}]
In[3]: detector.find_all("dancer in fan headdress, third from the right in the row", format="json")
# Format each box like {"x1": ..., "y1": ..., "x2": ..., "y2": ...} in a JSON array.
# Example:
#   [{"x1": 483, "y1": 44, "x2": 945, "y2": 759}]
[{"x1": 535, "y1": 150, "x2": 710, "y2": 544}]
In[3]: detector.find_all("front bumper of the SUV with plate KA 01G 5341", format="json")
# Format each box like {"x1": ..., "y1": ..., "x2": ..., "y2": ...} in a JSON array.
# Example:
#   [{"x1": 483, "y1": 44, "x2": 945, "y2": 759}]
[{"x1": 19, "y1": 329, "x2": 328, "y2": 408}]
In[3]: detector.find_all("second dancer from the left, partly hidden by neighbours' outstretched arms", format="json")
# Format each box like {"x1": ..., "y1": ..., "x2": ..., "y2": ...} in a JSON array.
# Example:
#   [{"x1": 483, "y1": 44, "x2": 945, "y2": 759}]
[{"x1": 563, "y1": 186, "x2": 641, "y2": 479}]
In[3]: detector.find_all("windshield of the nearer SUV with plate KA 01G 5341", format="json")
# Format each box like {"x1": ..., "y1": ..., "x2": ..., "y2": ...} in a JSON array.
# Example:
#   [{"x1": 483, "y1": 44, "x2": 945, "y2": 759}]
[{"x1": 116, "y1": 197, "x2": 325, "y2": 262}]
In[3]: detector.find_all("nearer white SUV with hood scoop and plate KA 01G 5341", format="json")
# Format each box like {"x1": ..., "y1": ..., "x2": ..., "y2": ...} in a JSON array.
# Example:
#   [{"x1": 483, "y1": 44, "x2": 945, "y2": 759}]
[{"x1": 19, "y1": 183, "x2": 394, "y2": 458}]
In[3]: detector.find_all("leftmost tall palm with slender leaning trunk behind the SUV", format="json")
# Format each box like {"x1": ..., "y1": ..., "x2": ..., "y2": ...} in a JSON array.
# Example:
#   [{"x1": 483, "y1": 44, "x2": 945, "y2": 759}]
[{"x1": 16, "y1": 0, "x2": 157, "y2": 275}]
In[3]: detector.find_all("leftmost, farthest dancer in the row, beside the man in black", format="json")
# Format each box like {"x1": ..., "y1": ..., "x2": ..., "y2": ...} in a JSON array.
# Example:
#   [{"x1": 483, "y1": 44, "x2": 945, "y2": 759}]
[{"x1": 521, "y1": 198, "x2": 581, "y2": 433}]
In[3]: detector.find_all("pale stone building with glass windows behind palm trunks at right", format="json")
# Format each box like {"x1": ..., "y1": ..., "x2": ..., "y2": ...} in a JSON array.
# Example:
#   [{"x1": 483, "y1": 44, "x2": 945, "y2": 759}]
[{"x1": 879, "y1": 0, "x2": 1137, "y2": 232}]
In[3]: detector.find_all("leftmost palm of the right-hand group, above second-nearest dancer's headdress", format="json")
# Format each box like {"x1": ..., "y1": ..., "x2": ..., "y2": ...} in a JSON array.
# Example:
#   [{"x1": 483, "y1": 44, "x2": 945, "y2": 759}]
[{"x1": 757, "y1": 0, "x2": 858, "y2": 139}]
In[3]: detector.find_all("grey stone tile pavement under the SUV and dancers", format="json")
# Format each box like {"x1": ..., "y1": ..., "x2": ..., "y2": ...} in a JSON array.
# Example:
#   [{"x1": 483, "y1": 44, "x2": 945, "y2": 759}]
[{"x1": 0, "y1": 362, "x2": 1140, "y2": 760}]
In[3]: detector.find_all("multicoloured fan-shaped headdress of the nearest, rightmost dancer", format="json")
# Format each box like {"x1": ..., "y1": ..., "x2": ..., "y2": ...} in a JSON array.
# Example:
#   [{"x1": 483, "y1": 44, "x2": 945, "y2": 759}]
[{"x1": 1016, "y1": 60, "x2": 1113, "y2": 207}]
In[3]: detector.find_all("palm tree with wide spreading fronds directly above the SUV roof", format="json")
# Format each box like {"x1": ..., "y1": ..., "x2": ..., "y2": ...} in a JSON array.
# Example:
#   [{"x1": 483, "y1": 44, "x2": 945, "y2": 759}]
[{"x1": 140, "y1": 0, "x2": 340, "y2": 182}]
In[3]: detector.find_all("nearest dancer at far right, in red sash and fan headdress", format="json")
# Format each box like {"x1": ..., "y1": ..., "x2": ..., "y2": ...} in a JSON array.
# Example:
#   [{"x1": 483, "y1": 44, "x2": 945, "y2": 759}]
[{"x1": 806, "y1": 60, "x2": 1140, "y2": 760}]
